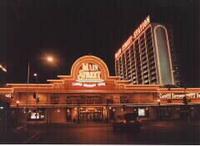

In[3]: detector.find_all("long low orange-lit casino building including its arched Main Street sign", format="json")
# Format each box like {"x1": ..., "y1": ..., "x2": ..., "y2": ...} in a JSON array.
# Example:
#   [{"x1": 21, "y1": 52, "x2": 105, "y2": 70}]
[{"x1": 0, "y1": 55, "x2": 200, "y2": 123}]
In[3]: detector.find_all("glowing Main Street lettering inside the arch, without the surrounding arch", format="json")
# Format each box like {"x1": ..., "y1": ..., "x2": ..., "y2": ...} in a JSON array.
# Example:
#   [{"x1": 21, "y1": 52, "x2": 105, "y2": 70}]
[{"x1": 72, "y1": 63, "x2": 105, "y2": 88}]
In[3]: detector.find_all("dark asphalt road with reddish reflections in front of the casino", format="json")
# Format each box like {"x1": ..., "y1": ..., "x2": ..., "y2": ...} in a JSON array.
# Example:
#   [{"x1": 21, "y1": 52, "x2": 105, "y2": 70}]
[{"x1": 0, "y1": 121, "x2": 200, "y2": 144}]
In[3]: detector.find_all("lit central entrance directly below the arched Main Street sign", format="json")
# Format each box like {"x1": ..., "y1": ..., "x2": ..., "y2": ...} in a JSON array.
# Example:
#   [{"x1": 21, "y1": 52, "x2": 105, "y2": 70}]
[{"x1": 67, "y1": 94, "x2": 111, "y2": 122}]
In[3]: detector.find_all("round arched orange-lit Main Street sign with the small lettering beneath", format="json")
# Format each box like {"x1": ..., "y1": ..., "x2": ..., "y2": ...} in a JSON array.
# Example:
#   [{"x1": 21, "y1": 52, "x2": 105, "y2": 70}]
[{"x1": 72, "y1": 56, "x2": 108, "y2": 88}]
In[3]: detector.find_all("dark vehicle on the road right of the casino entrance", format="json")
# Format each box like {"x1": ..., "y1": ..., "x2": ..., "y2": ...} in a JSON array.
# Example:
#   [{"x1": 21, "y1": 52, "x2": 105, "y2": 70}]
[{"x1": 113, "y1": 113, "x2": 142, "y2": 132}]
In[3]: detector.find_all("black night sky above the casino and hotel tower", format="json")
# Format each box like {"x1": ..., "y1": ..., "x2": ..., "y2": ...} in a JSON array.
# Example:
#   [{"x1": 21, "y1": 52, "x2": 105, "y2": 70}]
[{"x1": 0, "y1": 0, "x2": 200, "y2": 86}]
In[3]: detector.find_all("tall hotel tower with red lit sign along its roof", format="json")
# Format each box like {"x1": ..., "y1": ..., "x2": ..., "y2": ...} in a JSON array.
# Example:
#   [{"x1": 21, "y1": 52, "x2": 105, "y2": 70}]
[{"x1": 115, "y1": 16, "x2": 175, "y2": 85}]
